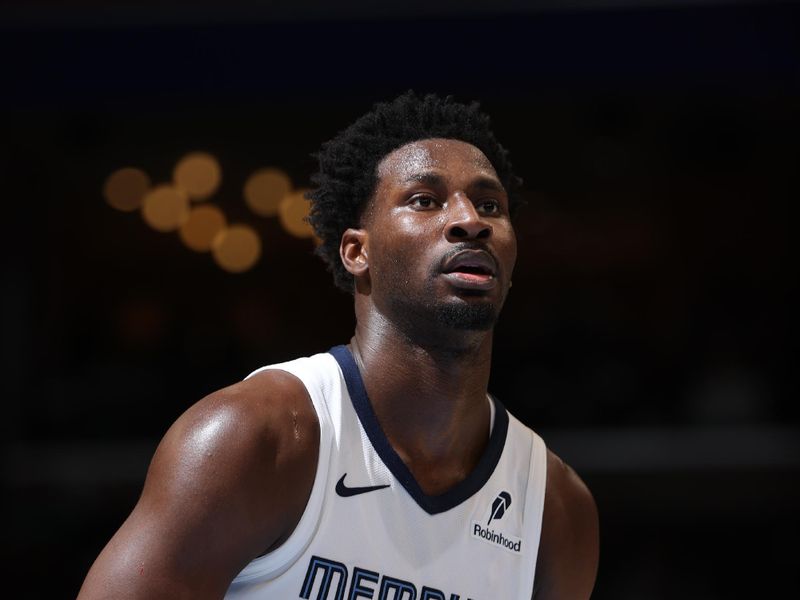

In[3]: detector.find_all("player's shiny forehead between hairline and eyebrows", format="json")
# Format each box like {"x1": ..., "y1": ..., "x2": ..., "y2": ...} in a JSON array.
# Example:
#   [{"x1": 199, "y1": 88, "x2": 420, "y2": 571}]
[{"x1": 377, "y1": 138, "x2": 496, "y2": 180}]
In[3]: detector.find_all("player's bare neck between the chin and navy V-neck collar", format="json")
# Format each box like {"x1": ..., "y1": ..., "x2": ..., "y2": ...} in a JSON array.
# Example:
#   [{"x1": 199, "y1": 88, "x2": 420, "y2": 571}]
[{"x1": 350, "y1": 312, "x2": 492, "y2": 495}]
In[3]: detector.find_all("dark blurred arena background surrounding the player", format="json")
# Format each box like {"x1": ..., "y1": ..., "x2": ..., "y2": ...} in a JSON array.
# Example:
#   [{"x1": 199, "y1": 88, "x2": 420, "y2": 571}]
[{"x1": 0, "y1": 0, "x2": 800, "y2": 600}]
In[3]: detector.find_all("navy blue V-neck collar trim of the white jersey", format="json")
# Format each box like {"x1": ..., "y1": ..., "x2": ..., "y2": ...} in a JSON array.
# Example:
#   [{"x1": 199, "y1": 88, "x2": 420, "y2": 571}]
[{"x1": 328, "y1": 346, "x2": 508, "y2": 515}]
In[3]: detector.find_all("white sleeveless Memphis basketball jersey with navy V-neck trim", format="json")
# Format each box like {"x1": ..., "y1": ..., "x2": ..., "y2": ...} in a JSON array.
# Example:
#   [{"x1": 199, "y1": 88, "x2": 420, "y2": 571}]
[{"x1": 225, "y1": 346, "x2": 547, "y2": 600}]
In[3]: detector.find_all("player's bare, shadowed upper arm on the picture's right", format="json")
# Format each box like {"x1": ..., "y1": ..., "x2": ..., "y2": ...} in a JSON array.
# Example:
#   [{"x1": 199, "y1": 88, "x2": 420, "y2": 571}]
[{"x1": 533, "y1": 451, "x2": 600, "y2": 600}]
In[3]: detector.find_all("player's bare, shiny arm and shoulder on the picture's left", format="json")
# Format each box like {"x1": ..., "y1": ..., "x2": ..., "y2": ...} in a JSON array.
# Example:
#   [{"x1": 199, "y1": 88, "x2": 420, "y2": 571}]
[{"x1": 79, "y1": 371, "x2": 319, "y2": 600}]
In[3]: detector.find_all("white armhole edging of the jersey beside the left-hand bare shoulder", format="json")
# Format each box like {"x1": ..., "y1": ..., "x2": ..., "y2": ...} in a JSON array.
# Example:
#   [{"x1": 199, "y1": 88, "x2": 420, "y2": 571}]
[{"x1": 231, "y1": 355, "x2": 333, "y2": 590}]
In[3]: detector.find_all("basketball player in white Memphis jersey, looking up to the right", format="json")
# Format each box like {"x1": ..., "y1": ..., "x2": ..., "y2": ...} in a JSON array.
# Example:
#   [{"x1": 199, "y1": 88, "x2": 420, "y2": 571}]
[{"x1": 80, "y1": 93, "x2": 598, "y2": 600}]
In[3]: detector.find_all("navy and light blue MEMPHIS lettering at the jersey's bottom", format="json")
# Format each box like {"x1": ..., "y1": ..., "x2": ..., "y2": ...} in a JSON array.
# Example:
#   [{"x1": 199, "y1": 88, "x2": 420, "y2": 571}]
[{"x1": 300, "y1": 556, "x2": 472, "y2": 600}]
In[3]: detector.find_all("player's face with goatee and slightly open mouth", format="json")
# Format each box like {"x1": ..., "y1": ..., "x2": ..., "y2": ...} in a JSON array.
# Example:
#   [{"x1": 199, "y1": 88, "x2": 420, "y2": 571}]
[{"x1": 364, "y1": 139, "x2": 517, "y2": 330}]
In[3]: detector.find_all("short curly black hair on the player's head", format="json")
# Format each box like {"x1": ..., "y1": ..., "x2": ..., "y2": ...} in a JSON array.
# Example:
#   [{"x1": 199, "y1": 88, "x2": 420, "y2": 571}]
[{"x1": 307, "y1": 90, "x2": 523, "y2": 292}]
